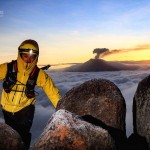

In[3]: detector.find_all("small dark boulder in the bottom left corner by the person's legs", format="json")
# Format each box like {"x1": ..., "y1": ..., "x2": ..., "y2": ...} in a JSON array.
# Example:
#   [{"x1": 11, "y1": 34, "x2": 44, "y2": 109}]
[{"x1": 0, "y1": 123, "x2": 23, "y2": 150}]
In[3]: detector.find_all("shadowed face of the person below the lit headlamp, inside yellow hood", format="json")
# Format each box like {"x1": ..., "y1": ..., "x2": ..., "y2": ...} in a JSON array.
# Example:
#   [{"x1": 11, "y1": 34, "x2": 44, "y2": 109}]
[{"x1": 21, "y1": 53, "x2": 37, "y2": 63}]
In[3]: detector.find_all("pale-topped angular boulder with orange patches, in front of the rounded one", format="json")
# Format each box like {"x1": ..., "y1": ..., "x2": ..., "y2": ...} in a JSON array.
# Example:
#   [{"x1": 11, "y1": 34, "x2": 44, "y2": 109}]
[{"x1": 33, "y1": 109, "x2": 116, "y2": 150}]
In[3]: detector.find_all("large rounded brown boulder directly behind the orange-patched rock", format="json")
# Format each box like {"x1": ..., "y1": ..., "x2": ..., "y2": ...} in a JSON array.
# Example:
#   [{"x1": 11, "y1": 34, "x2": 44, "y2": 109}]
[{"x1": 56, "y1": 79, "x2": 126, "y2": 132}]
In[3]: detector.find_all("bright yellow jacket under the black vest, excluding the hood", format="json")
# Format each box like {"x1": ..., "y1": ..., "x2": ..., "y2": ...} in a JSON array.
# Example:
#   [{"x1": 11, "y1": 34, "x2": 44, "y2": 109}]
[{"x1": 0, "y1": 54, "x2": 60, "y2": 113}]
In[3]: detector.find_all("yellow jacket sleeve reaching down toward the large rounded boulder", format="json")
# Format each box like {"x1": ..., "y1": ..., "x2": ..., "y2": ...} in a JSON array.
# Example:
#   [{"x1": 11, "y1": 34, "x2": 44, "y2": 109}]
[{"x1": 36, "y1": 69, "x2": 61, "y2": 108}]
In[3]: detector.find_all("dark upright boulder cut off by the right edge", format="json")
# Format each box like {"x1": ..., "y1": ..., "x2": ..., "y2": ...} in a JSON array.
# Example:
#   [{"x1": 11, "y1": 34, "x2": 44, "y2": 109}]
[{"x1": 133, "y1": 76, "x2": 150, "y2": 149}]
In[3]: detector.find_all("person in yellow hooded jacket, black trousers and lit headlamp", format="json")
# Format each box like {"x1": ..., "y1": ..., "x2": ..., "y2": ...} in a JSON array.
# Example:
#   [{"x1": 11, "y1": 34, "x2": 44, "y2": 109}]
[{"x1": 0, "y1": 39, "x2": 60, "y2": 149}]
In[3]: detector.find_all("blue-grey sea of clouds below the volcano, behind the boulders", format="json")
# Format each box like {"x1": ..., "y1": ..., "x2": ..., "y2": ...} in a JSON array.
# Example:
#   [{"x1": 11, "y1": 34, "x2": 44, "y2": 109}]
[{"x1": 0, "y1": 70, "x2": 150, "y2": 144}]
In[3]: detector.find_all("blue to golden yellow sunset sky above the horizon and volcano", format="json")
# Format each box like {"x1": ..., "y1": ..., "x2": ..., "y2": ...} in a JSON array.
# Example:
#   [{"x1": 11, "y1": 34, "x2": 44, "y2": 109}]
[{"x1": 0, "y1": 0, "x2": 150, "y2": 64}]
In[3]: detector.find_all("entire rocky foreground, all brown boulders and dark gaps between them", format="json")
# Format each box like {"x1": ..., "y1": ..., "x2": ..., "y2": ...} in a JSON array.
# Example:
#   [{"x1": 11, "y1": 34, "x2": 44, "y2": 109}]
[{"x1": 0, "y1": 76, "x2": 150, "y2": 150}]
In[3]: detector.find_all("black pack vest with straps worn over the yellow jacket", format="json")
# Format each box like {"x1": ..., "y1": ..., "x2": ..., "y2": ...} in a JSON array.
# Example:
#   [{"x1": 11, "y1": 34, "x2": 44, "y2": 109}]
[{"x1": 3, "y1": 60, "x2": 40, "y2": 98}]
